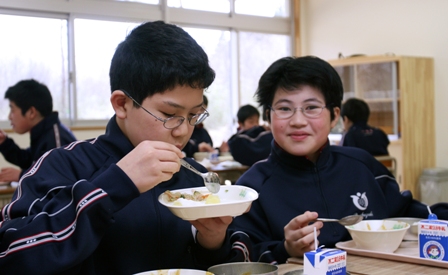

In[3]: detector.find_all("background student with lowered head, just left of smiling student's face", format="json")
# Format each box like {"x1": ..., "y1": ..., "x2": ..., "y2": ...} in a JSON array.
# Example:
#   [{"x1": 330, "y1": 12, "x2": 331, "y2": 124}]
[{"x1": 227, "y1": 105, "x2": 272, "y2": 166}]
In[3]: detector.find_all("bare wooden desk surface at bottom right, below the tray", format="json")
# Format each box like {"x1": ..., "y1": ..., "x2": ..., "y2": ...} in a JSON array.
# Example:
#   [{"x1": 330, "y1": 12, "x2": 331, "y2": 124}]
[{"x1": 284, "y1": 254, "x2": 448, "y2": 275}]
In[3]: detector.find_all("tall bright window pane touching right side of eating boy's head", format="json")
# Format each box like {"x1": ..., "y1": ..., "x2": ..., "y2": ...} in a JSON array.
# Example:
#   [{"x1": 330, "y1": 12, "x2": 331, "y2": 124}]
[{"x1": 184, "y1": 28, "x2": 235, "y2": 147}]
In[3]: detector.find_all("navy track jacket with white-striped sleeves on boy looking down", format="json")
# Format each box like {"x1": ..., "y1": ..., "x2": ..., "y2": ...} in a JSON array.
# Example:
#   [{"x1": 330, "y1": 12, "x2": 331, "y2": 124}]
[{"x1": 0, "y1": 117, "x2": 234, "y2": 274}]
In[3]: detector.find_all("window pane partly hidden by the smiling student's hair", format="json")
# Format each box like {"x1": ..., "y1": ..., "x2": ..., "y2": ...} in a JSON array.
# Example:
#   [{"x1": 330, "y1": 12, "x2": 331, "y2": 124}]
[{"x1": 239, "y1": 32, "x2": 291, "y2": 112}]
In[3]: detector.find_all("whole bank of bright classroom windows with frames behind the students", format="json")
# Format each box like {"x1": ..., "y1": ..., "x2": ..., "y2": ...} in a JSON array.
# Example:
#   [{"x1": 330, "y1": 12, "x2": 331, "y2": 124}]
[{"x1": 0, "y1": 0, "x2": 292, "y2": 146}]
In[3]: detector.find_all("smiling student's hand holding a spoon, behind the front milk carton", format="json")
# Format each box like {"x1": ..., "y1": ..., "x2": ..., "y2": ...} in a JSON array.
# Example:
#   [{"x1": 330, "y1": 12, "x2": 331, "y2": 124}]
[{"x1": 284, "y1": 211, "x2": 323, "y2": 257}]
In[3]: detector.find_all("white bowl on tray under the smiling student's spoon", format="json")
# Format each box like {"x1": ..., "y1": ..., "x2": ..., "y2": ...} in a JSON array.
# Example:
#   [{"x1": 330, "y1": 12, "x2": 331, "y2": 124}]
[{"x1": 345, "y1": 220, "x2": 410, "y2": 253}]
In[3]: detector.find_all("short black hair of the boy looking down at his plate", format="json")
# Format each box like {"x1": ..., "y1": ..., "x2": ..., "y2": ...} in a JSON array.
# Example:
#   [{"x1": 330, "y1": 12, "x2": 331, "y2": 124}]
[{"x1": 109, "y1": 21, "x2": 215, "y2": 103}]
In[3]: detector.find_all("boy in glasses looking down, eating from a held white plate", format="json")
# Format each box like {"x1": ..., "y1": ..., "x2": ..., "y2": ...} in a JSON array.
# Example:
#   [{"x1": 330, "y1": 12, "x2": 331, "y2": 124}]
[{"x1": 0, "y1": 21, "x2": 238, "y2": 274}]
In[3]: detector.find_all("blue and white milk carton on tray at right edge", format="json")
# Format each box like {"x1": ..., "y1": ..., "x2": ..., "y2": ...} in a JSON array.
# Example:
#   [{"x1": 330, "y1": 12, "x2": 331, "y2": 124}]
[{"x1": 418, "y1": 214, "x2": 448, "y2": 261}]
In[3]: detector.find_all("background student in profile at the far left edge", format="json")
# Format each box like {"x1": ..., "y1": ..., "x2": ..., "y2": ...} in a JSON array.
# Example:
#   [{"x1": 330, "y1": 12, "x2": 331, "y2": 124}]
[{"x1": 0, "y1": 79, "x2": 76, "y2": 182}]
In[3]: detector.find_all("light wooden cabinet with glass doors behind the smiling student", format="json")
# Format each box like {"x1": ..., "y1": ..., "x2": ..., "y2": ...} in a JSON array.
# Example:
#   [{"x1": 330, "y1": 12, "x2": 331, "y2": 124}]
[{"x1": 329, "y1": 56, "x2": 435, "y2": 198}]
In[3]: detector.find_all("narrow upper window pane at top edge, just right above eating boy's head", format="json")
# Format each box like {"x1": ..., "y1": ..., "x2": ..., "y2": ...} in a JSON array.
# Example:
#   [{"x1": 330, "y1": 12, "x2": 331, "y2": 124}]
[{"x1": 167, "y1": 0, "x2": 230, "y2": 13}]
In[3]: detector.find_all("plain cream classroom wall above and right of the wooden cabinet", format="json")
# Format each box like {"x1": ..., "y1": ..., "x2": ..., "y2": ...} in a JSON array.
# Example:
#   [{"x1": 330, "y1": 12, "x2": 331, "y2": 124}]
[{"x1": 300, "y1": 0, "x2": 448, "y2": 168}]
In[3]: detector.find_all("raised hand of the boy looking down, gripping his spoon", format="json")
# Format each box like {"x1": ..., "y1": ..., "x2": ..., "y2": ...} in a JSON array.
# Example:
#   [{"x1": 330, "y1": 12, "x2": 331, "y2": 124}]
[{"x1": 117, "y1": 140, "x2": 183, "y2": 193}]
